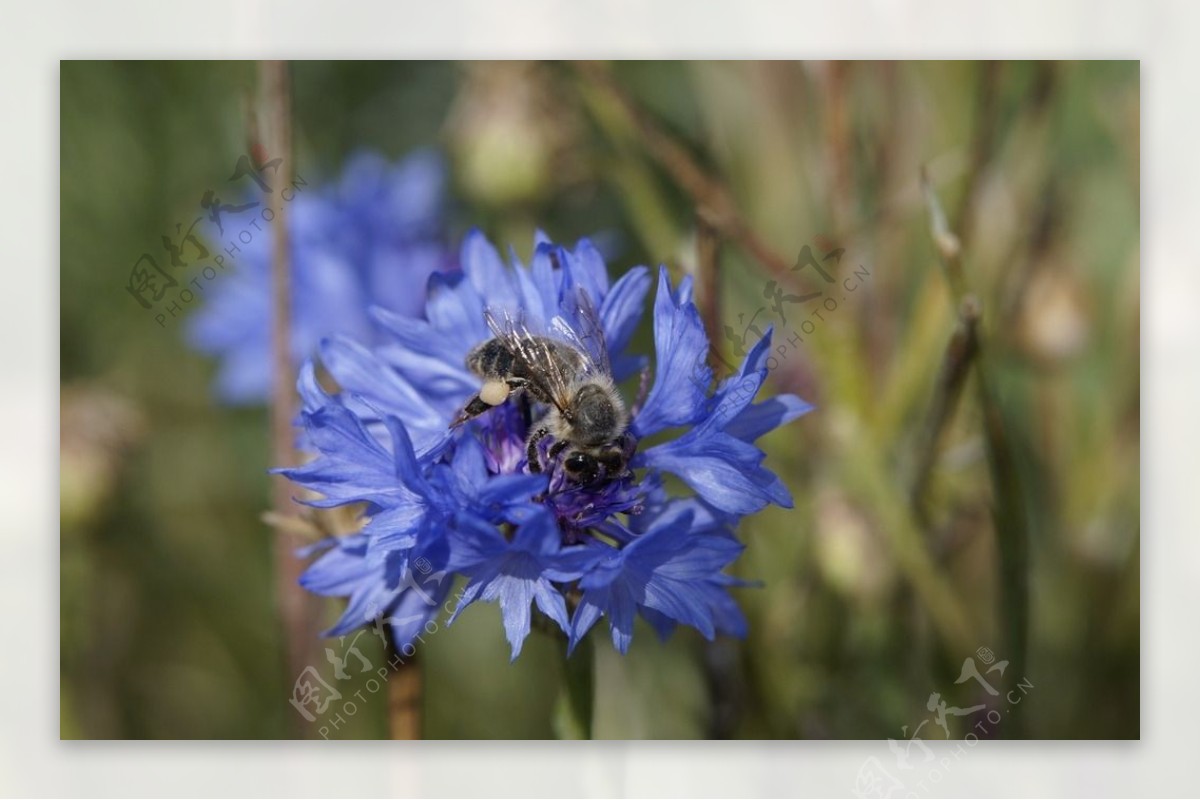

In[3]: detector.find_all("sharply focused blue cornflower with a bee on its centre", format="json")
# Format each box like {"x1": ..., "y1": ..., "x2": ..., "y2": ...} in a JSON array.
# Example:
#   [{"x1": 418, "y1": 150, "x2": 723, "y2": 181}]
[{"x1": 281, "y1": 231, "x2": 810, "y2": 658}]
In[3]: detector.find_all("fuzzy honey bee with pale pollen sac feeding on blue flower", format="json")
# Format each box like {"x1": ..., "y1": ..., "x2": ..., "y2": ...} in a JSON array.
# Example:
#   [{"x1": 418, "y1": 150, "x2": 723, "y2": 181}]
[{"x1": 450, "y1": 290, "x2": 631, "y2": 485}]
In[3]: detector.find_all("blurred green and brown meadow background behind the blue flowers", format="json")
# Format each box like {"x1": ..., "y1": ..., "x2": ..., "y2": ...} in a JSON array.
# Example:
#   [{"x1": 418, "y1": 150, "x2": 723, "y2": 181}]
[{"x1": 60, "y1": 62, "x2": 1139, "y2": 739}]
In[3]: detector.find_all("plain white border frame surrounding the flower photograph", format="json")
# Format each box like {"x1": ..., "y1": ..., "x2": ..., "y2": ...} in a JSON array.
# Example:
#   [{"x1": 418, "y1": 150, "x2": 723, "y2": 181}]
[{"x1": 7, "y1": 0, "x2": 1200, "y2": 798}]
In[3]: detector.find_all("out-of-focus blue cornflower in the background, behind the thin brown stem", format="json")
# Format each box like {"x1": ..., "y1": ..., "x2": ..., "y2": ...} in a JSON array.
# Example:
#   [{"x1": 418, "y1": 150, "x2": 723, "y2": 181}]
[{"x1": 187, "y1": 151, "x2": 454, "y2": 403}]
